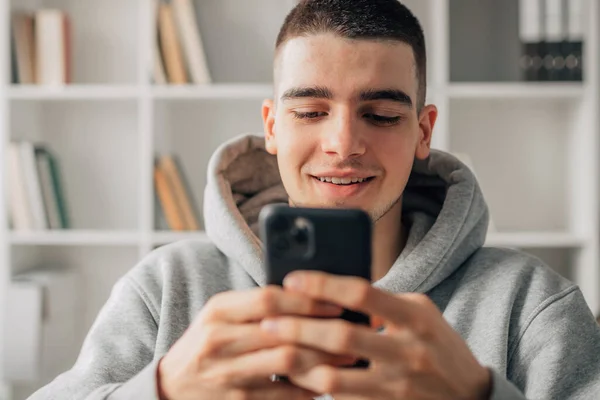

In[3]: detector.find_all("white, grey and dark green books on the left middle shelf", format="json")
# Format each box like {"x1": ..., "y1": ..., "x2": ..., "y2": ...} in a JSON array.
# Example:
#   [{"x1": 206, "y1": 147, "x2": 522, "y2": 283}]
[{"x1": 8, "y1": 141, "x2": 69, "y2": 231}]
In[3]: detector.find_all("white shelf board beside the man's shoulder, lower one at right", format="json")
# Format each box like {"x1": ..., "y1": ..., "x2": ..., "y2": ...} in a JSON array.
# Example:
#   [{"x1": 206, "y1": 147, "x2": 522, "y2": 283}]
[{"x1": 485, "y1": 232, "x2": 586, "y2": 249}]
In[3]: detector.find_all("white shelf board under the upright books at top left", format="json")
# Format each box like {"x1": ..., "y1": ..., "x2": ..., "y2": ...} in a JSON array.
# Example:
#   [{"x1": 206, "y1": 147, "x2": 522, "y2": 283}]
[{"x1": 8, "y1": 85, "x2": 140, "y2": 100}]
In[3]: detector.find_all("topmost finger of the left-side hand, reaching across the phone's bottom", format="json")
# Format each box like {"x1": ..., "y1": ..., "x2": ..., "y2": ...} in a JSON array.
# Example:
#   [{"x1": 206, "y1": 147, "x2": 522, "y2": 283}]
[{"x1": 200, "y1": 286, "x2": 342, "y2": 322}]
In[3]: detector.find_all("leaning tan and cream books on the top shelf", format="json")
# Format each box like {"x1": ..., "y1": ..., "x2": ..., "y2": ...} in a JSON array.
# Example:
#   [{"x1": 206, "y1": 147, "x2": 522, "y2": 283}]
[{"x1": 153, "y1": 0, "x2": 212, "y2": 85}]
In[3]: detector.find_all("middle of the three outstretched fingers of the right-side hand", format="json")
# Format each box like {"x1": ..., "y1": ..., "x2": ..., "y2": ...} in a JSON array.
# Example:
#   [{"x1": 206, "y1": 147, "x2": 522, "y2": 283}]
[{"x1": 260, "y1": 317, "x2": 400, "y2": 361}]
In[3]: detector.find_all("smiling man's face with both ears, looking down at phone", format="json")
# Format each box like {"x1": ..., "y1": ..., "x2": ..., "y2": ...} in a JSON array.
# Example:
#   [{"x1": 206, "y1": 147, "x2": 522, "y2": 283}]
[{"x1": 263, "y1": 34, "x2": 437, "y2": 221}]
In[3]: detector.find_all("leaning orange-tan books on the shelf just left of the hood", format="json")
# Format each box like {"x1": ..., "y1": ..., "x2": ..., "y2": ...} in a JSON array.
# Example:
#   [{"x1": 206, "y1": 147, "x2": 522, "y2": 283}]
[{"x1": 154, "y1": 154, "x2": 200, "y2": 231}]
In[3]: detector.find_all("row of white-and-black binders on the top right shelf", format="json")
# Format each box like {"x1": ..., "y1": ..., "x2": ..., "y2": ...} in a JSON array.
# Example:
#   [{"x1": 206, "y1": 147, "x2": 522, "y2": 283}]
[{"x1": 519, "y1": 0, "x2": 586, "y2": 81}]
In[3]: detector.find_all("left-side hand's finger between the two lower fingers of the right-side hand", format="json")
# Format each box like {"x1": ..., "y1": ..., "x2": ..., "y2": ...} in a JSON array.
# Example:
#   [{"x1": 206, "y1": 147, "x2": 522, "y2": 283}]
[{"x1": 216, "y1": 345, "x2": 350, "y2": 386}]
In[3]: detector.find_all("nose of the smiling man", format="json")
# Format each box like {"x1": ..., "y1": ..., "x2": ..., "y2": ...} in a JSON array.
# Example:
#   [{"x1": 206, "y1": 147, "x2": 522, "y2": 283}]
[{"x1": 321, "y1": 113, "x2": 366, "y2": 160}]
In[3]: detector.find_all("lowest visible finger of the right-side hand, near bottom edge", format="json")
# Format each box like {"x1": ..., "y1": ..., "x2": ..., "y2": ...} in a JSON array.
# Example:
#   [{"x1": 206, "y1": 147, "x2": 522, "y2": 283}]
[{"x1": 289, "y1": 365, "x2": 384, "y2": 400}]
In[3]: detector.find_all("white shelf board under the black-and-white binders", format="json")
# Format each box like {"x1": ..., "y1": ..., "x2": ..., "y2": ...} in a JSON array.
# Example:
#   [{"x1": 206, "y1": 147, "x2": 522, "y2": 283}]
[{"x1": 447, "y1": 82, "x2": 585, "y2": 100}]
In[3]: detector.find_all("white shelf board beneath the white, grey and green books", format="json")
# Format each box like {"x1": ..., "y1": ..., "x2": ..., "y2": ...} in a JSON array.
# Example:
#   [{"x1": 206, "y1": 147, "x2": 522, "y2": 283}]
[{"x1": 10, "y1": 230, "x2": 140, "y2": 246}]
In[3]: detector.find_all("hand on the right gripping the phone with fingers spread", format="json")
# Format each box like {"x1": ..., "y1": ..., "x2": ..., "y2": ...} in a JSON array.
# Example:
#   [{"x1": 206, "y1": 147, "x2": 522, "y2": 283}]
[{"x1": 261, "y1": 271, "x2": 491, "y2": 400}]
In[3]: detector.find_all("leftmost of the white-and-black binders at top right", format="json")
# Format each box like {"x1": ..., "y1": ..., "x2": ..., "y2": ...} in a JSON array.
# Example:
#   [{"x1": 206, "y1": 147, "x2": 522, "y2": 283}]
[{"x1": 519, "y1": 0, "x2": 543, "y2": 81}]
